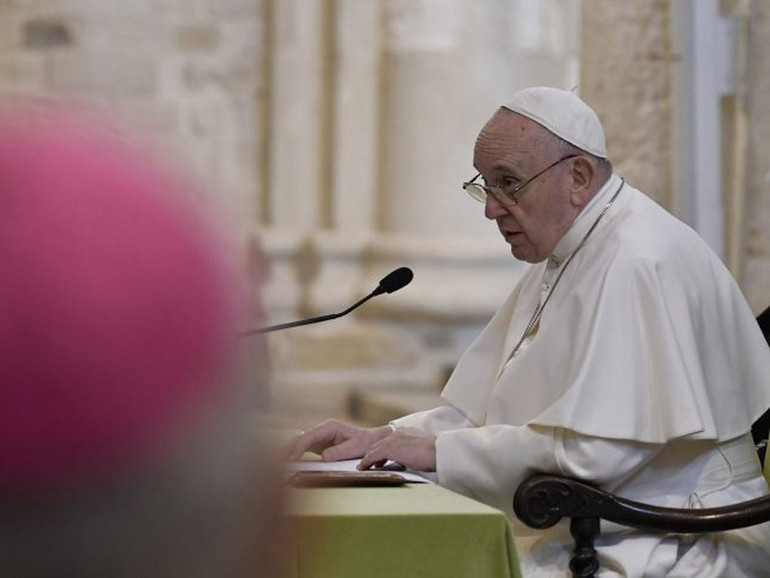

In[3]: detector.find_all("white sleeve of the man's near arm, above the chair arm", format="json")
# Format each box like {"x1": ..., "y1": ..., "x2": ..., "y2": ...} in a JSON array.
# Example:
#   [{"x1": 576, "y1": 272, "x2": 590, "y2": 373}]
[{"x1": 436, "y1": 425, "x2": 663, "y2": 514}]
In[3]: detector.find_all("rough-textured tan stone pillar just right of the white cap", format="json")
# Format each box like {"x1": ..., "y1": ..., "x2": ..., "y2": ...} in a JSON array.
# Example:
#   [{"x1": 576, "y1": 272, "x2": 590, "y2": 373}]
[{"x1": 579, "y1": 0, "x2": 674, "y2": 209}]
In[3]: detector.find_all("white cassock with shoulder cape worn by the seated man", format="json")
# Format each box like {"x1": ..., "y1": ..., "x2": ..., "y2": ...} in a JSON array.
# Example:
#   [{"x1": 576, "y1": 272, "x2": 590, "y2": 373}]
[{"x1": 394, "y1": 176, "x2": 770, "y2": 578}]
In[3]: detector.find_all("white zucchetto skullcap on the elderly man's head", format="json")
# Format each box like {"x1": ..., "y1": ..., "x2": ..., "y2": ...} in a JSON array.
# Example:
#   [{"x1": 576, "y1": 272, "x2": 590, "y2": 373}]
[{"x1": 502, "y1": 86, "x2": 607, "y2": 158}]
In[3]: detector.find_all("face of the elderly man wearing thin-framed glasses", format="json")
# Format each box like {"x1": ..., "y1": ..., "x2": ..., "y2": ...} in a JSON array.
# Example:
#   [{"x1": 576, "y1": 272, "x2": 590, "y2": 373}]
[{"x1": 473, "y1": 109, "x2": 579, "y2": 263}]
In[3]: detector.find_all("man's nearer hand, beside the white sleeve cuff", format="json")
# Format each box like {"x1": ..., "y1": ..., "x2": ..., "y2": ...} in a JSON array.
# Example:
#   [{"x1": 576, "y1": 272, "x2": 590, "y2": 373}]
[{"x1": 357, "y1": 427, "x2": 436, "y2": 472}]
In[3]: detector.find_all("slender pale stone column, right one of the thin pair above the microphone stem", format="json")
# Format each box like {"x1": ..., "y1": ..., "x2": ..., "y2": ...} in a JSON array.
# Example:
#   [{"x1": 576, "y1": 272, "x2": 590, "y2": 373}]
[{"x1": 309, "y1": 0, "x2": 382, "y2": 312}]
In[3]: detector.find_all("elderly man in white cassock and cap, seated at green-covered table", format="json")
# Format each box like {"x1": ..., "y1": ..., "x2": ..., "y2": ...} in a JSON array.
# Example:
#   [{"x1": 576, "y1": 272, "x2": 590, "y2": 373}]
[{"x1": 294, "y1": 88, "x2": 770, "y2": 578}]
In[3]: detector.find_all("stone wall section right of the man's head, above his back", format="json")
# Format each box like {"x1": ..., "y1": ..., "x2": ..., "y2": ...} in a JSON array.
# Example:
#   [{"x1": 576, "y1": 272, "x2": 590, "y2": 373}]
[{"x1": 580, "y1": 0, "x2": 770, "y2": 313}]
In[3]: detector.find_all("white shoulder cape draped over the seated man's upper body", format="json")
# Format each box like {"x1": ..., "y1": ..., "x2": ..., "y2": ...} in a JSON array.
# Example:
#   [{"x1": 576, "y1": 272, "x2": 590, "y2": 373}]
[{"x1": 442, "y1": 177, "x2": 770, "y2": 443}]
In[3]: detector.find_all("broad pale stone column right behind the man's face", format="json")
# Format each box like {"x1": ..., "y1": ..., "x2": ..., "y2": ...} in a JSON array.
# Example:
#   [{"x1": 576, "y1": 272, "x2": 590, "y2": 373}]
[{"x1": 372, "y1": 0, "x2": 579, "y2": 324}]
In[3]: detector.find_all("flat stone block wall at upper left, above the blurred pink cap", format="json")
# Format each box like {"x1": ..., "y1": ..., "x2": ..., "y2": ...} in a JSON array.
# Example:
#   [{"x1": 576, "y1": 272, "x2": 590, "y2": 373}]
[{"x1": 0, "y1": 0, "x2": 264, "y2": 238}]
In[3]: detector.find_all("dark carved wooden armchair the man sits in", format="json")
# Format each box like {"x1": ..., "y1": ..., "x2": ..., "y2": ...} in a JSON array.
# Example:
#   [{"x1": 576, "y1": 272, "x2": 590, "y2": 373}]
[{"x1": 513, "y1": 308, "x2": 770, "y2": 578}]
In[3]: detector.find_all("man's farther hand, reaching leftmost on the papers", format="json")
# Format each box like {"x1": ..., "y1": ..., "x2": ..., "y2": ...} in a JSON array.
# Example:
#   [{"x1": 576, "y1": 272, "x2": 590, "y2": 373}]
[{"x1": 289, "y1": 419, "x2": 391, "y2": 462}]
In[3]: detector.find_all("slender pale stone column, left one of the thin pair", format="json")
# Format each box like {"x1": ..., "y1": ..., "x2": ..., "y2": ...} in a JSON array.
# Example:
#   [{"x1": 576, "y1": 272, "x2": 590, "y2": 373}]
[{"x1": 260, "y1": 0, "x2": 329, "y2": 322}]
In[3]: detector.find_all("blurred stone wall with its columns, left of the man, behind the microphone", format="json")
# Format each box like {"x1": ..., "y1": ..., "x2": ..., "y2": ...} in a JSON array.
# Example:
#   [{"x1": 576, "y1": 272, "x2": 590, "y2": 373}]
[{"x1": 0, "y1": 0, "x2": 579, "y2": 424}]
